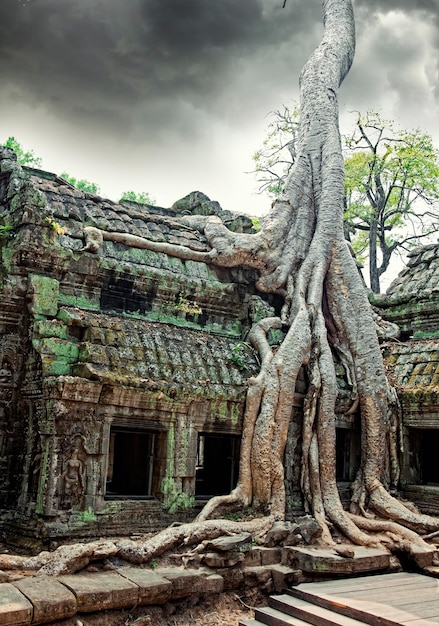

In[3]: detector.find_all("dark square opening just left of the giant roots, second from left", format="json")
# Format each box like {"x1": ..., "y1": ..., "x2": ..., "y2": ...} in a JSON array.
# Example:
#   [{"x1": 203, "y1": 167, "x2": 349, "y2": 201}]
[{"x1": 195, "y1": 433, "x2": 241, "y2": 498}]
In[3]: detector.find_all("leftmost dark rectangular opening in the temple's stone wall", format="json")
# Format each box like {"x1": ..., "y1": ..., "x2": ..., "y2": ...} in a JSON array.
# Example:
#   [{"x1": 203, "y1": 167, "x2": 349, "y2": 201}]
[{"x1": 106, "y1": 428, "x2": 156, "y2": 499}]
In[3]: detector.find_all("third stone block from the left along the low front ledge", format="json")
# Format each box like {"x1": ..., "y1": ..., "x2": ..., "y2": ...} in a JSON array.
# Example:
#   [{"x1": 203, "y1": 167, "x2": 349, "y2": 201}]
[{"x1": 58, "y1": 572, "x2": 139, "y2": 613}]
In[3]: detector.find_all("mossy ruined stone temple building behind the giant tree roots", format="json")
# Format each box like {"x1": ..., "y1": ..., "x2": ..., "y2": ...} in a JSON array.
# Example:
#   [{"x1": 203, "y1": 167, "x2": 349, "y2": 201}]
[{"x1": 0, "y1": 148, "x2": 439, "y2": 549}]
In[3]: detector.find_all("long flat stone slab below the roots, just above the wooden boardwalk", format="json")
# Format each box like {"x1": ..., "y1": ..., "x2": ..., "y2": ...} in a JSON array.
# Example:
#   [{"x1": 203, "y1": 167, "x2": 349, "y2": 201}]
[{"x1": 283, "y1": 546, "x2": 390, "y2": 574}]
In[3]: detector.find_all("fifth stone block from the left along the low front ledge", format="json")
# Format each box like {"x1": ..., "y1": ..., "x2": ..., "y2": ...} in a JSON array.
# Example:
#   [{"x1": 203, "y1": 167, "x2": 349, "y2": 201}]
[{"x1": 155, "y1": 567, "x2": 224, "y2": 600}]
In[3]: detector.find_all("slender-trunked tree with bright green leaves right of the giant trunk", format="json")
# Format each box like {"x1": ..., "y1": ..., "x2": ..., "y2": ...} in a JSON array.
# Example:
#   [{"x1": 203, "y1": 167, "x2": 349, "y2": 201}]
[{"x1": 344, "y1": 111, "x2": 439, "y2": 293}]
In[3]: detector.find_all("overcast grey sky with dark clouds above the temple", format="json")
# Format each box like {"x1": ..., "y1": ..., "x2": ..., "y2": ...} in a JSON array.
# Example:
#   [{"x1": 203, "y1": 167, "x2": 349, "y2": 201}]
[{"x1": 0, "y1": 0, "x2": 439, "y2": 222}]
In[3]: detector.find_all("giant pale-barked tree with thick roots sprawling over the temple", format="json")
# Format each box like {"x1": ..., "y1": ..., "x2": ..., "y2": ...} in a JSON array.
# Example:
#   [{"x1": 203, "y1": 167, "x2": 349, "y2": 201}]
[{"x1": 6, "y1": 0, "x2": 439, "y2": 572}]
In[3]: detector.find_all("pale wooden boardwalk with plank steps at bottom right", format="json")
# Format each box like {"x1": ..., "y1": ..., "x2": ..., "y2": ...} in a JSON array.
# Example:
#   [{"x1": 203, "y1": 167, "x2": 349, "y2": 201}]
[{"x1": 242, "y1": 572, "x2": 439, "y2": 626}]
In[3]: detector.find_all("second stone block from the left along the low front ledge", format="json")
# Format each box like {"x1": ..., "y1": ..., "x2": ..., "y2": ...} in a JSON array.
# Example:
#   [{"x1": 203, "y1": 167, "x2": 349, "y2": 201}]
[{"x1": 13, "y1": 576, "x2": 76, "y2": 624}]
